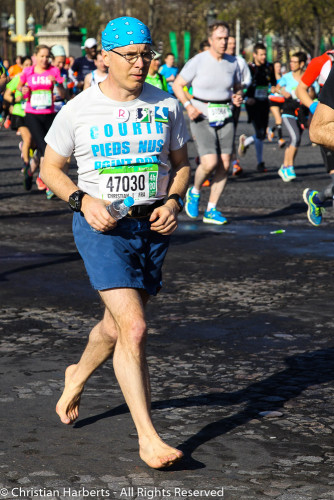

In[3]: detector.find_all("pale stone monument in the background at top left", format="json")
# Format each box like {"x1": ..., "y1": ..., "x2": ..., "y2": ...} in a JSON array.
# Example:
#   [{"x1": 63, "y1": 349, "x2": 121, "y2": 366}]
[{"x1": 36, "y1": 0, "x2": 82, "y2": 57}]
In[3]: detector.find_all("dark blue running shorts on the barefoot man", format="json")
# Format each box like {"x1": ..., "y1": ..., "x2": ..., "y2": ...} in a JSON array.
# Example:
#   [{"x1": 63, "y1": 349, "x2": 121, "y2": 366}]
[{"x1": 73, "y1": 212, "x2": 170, "y2": 295}]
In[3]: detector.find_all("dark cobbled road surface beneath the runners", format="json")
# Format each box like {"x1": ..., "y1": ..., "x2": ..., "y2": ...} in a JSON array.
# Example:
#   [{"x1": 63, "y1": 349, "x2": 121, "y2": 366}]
[{"x1": 0, "y1": 114, "x2": 334, "y2": 500}]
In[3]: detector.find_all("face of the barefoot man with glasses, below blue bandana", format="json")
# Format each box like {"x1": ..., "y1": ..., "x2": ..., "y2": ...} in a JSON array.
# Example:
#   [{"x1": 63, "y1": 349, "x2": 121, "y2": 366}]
[{"x1": 102, "y1": 43, "x2": 151, "y2": 92}]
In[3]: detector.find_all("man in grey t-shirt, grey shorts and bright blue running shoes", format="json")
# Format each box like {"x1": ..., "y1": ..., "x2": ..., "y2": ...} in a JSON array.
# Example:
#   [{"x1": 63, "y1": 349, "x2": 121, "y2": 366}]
[{"x1": 173, "y1": 21, "x2": 242, "y2": 224}]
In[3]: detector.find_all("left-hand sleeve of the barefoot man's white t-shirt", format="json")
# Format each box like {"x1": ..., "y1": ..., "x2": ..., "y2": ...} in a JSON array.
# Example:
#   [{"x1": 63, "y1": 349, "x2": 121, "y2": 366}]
[{"x1": 45, "y1": 104, "x2": 75, "y2": 158}]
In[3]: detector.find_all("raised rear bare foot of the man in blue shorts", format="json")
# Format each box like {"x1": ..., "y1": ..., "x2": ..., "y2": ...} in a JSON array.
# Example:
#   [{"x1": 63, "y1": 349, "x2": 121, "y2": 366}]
[{"x1": 56, "y1": 365, "x2": 84, "y2": 424}]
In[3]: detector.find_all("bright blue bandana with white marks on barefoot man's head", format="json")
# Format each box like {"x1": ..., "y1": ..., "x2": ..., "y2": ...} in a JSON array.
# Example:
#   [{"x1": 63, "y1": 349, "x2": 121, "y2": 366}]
[{"x1": 101, "y1": 17, "x2": 152, "y2": 51}]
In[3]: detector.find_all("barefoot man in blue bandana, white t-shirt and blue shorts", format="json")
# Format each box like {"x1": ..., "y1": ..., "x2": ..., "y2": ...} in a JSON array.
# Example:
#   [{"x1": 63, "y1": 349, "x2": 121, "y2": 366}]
[{"x1": 42, "y1": 17, "x2": 190, "y2": 468}]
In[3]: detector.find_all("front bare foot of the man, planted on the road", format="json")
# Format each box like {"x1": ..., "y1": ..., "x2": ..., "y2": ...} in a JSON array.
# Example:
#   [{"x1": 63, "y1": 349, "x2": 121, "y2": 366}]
[{"x1": 139, "y1": 435, "x2": 183, "y2": 469}]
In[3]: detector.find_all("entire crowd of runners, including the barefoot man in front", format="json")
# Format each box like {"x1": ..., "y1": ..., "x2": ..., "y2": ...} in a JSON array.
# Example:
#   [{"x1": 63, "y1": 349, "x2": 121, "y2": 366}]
[{"x1": 0, "y1": 16, "x2": 334, "y2": 469}]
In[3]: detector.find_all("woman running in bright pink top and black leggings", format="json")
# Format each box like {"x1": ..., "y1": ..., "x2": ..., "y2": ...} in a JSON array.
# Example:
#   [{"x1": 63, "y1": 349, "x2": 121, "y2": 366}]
[{"x1": 20, "y1": 45, "x2": 65, "y2": 199}]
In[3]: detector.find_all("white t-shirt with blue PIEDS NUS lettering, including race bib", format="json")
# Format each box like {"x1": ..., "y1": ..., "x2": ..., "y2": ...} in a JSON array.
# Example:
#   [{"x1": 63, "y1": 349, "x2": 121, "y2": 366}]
[{"x1": 45, "y1": 83, "x2": 189, "y2": 205}]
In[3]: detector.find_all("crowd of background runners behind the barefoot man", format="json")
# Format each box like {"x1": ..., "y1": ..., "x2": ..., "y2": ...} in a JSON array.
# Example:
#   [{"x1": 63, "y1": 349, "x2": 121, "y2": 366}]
[{"x1": 0, "y1": 22, "x2": 334, "y2": 226}]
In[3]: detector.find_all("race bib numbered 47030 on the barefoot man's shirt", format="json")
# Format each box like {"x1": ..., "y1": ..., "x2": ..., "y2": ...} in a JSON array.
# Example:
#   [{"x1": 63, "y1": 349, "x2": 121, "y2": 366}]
[{"x1": 99, "y1": 163, "x2": 159, "y2": 201}]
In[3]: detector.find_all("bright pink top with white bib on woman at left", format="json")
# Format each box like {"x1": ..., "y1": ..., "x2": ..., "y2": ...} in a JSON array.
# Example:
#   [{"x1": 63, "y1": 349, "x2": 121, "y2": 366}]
[{"x1": 20, "y1": 66, "x2": 64, "y2": 115}]
